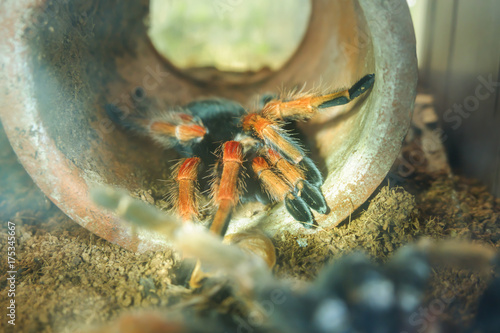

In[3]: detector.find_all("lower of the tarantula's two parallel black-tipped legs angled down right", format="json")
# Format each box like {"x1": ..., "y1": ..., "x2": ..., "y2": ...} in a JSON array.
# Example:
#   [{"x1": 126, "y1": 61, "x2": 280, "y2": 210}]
[{"x1": 252, "y1": 157, "x2": 314, "y2": 228}]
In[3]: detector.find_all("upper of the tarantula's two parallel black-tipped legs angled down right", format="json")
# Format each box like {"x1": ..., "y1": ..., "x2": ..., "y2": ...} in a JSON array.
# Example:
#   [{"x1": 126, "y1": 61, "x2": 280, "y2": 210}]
[{"x1": 267, "y1": 149, "x2": 329, "y2": 214}]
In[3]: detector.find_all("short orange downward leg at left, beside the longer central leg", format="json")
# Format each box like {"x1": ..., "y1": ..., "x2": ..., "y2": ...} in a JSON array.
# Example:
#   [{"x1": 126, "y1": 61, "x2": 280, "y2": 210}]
[{"x1": 173, "y1": 157, "x2": 201, "y2": 221}]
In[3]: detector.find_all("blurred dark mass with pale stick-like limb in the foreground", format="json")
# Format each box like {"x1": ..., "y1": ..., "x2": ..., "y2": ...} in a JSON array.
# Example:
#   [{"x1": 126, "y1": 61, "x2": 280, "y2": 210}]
[{"x1": 90, "y1": 189, "x2": 500, "y2": 333}]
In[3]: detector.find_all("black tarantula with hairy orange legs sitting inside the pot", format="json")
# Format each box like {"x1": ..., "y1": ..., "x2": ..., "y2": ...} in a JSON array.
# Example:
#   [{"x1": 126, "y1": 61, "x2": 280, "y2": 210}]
[{"x1": 106, "y1": 74, "x2": 375, "y2": 236}]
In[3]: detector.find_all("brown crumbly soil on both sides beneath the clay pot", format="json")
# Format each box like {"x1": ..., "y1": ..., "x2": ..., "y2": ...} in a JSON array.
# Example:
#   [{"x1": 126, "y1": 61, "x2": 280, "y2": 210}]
[{"x1": 0, "y1": 109, "x2": 500, "y2": 332}]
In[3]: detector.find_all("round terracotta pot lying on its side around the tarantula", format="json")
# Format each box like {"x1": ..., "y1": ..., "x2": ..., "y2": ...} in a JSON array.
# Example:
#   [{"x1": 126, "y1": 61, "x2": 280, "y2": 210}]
[{"x1": 2, "y1": 0, "x2": 417, "y2": 248}]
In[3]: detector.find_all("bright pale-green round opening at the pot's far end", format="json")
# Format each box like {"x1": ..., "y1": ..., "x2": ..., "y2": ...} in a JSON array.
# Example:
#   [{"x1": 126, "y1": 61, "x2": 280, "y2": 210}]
[{"x1": 149, "y1": 0, "x2": 311, "y2": 72}]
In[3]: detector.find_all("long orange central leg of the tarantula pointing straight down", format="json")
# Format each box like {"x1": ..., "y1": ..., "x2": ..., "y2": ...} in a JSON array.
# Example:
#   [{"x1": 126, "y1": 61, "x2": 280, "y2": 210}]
[{"x1": 210, "y1": 141, "x2": 243, "y2": 236}]
